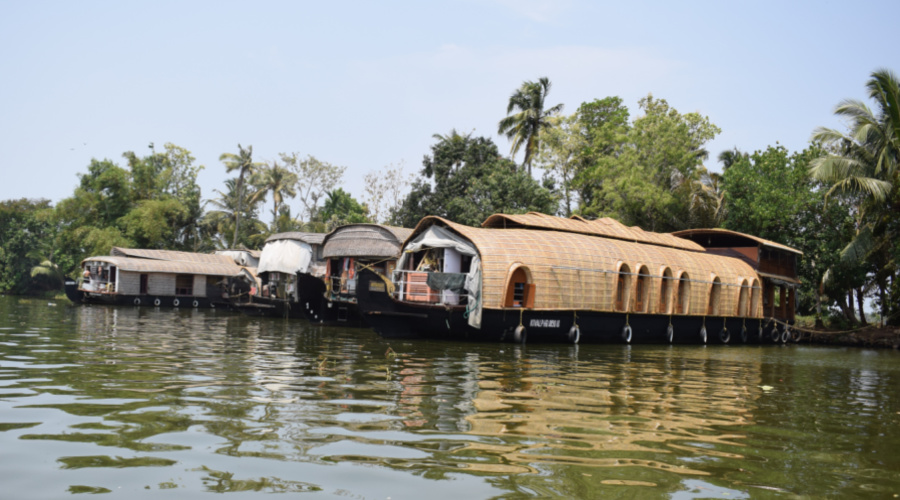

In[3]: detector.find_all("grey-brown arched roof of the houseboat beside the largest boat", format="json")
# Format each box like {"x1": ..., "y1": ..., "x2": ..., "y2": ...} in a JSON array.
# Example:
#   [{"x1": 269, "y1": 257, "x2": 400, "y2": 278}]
[{"x1": 322, "y1": 224, "x2": 412, "y2": 259}]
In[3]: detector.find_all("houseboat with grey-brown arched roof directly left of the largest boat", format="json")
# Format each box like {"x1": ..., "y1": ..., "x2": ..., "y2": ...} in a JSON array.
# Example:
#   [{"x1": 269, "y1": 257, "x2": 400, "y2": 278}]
[{"x1": 297, "y1": 224, "x2": 412, "y2": 327}]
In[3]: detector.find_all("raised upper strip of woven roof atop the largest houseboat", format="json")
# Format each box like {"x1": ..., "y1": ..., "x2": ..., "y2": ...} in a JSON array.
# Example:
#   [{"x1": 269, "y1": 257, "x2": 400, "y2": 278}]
[{"x1": 481, "y1": 212, "x2": 703, "y2": 251}]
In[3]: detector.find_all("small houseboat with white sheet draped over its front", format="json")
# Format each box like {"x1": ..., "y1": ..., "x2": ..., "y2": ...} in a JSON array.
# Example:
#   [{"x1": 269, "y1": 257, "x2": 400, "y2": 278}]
[{"x1": 230, "y1": 231, "x2": 325, "y2": 319}]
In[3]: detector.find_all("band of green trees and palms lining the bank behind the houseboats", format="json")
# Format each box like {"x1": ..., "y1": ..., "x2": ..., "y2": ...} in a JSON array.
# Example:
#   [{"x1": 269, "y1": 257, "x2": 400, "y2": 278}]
[{"x1": 0, "y1": 70, "x2": 900, "y2": 325}]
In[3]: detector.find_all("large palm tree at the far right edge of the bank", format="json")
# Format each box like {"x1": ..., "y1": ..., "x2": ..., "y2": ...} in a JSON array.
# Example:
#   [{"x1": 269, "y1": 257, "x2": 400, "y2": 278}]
[{"x1": 810, "y1": 69, "x2": 900, "y2": 322}]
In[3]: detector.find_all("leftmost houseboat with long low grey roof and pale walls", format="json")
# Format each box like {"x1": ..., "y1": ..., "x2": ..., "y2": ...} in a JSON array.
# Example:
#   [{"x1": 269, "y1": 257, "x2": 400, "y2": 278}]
[{"x1": 66, "y1": 247, "x2": 253, "y2": 307}]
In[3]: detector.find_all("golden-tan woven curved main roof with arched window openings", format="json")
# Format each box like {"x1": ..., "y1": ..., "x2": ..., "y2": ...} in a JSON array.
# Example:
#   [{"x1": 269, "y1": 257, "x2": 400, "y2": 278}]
[{"x1": 413, "y1": 217, "x2": 761, "y2": 316}]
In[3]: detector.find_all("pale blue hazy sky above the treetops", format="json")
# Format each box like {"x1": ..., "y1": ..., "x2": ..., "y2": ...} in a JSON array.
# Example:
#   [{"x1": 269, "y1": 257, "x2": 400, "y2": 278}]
[{"x1": 0, "y1": 0, "x2": 900, "y2": 213}]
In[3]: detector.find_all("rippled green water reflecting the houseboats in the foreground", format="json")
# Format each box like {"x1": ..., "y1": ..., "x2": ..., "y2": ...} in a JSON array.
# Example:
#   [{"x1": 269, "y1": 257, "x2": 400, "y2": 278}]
[{"x1": 0, "y1": 297, "x2": 900, "y2": 500}]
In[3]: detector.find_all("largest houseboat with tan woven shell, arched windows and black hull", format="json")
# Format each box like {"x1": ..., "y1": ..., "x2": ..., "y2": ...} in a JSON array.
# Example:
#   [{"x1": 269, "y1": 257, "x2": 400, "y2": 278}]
[{"x1": 357, "y1": 213, "x2": 801, "y2": 344}]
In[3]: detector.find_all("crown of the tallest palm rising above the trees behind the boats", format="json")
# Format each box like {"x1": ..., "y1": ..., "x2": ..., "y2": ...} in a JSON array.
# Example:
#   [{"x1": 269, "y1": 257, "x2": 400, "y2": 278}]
[{"x1": 497, "y1": 76, "x2": 563, "y2": 175}]
